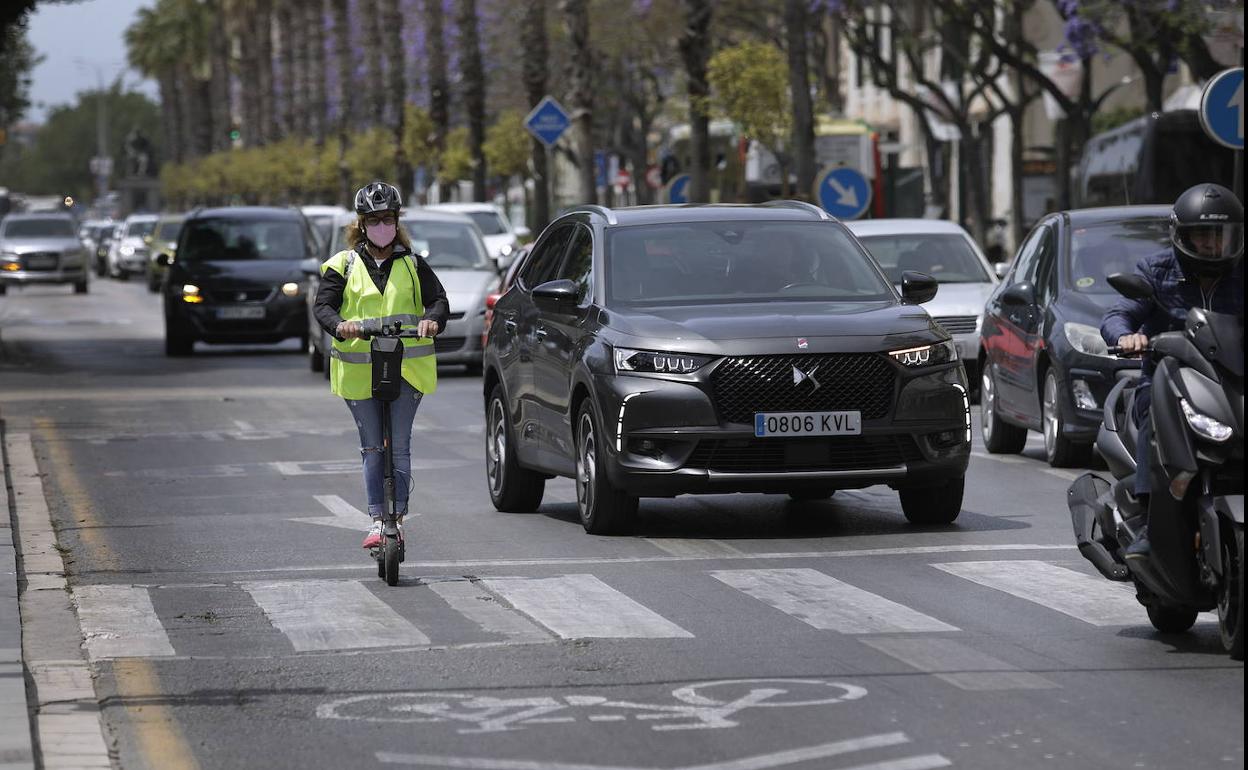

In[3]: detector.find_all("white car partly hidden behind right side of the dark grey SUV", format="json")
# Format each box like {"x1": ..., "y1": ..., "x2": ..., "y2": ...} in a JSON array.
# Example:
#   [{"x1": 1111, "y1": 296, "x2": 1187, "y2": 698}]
[{"x1": 845, "y1": 220, "x2": 998, "y2": 383}]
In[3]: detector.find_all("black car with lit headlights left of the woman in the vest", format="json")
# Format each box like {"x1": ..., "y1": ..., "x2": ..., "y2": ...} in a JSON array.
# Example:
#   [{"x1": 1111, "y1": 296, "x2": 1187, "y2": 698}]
[{"x1": 161, "y1": 206, "x2": 318, "y2": 356}]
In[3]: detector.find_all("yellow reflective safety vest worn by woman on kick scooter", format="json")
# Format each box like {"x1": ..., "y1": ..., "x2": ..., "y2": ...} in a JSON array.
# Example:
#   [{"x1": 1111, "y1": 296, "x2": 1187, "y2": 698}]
[{"x1": 321, "y1": 251, "x2": 438, "y2": 401}]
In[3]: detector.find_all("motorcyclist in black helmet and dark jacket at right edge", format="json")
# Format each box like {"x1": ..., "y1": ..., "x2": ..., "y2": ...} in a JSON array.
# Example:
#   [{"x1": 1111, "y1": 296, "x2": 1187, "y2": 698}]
[{"x1": 1101, "y1": 183, "x2": 1244, "y2": 558}]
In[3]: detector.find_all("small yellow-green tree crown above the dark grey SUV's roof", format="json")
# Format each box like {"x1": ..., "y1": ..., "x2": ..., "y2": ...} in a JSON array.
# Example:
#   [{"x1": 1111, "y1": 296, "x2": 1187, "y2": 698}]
[{"x1": 706, "y1": 41, "x2": 792, "y2": 151}]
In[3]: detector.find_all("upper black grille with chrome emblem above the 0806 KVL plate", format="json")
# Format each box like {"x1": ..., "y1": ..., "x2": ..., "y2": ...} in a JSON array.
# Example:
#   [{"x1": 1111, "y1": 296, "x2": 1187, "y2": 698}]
[{"x1": 710, "y1": 353, "x2": 896, "y2": 423}]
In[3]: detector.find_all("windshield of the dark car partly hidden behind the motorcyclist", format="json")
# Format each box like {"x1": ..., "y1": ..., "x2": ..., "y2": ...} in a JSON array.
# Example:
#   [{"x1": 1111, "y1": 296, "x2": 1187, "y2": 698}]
[{"x1": 1070, "y1": 218, "x2": 1171, "y2": 296}]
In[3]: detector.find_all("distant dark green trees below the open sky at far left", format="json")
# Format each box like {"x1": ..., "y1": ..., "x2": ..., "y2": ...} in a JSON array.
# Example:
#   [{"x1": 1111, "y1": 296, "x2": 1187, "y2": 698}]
[{"x1": 0, "y1": 85, "x2": 161, "y2": 200}]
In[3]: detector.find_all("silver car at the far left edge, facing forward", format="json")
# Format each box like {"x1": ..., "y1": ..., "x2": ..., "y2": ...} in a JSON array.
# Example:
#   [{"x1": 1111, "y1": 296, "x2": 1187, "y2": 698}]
[{"x1": 0, "y1": 213, "x2": 90, "y2": 295}]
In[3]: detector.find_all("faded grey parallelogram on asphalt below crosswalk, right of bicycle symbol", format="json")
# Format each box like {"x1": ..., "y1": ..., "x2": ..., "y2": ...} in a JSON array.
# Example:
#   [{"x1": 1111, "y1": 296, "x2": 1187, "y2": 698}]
[{"x1": 862, "y1": 636, "x2": 1057, "y2": 691}]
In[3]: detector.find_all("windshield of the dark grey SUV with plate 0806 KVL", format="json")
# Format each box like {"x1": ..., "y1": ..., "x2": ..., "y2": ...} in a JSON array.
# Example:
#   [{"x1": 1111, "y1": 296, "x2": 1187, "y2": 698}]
[{"x1": 605, "y1": 221, "x2": 894, "y2": 306}]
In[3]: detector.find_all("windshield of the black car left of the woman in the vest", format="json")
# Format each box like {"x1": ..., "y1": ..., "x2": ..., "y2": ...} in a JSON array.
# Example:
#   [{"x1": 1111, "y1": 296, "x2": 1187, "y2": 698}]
[{"x1": 177, "y1": 217, "x2": 308, "y2": 262}]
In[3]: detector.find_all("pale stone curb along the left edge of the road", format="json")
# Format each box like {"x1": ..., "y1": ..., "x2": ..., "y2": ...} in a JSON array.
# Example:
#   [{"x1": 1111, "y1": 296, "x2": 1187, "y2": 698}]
[{"x1": 0, "y1": 432, "x2": 112, "y2": 770}]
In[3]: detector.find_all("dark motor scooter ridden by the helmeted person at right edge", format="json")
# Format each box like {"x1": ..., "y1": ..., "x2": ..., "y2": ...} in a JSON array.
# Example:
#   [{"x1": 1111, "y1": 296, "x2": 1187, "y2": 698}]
[{"x1": 1067, "y1": 275, "x2": 1244, "y2": 660}]
